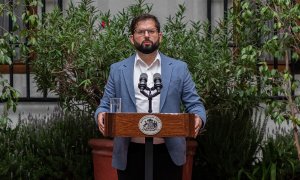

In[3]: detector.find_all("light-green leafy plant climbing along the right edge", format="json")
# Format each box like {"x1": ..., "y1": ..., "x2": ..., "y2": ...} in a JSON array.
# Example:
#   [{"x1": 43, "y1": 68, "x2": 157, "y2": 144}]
[{"x1": 230, "y1": 0, "x2": 300, "y2": 160}]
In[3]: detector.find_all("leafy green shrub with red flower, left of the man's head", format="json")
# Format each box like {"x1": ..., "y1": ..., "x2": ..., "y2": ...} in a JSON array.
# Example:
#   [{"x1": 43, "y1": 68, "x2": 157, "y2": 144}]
[{"x1": 33, "y1": 0, "x2": 151, "y2": 112}]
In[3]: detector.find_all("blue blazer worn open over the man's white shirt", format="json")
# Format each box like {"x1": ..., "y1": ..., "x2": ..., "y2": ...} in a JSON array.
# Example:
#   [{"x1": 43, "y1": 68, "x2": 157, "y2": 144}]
[{"x1": 95, "y1": 53, "x2": 206, "y2": 170}]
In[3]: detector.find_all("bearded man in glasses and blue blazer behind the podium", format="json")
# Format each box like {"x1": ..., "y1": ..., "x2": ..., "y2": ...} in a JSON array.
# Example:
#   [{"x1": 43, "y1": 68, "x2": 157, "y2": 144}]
[{"x1": 95, "y1": 14, "x2": 206, "y2": 180}]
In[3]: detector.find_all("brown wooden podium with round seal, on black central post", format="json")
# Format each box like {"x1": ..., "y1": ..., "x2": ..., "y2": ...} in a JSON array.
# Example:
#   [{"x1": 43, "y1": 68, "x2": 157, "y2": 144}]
[{"x1": 104, "y1": 113, "x2": 195, "y2": 180}]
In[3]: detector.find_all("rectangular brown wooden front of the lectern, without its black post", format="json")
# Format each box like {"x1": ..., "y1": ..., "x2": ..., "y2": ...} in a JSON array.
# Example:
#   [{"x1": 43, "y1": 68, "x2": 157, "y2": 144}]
[{"x1": 104, "y1": 113, "x2": 195, "y2": 137}]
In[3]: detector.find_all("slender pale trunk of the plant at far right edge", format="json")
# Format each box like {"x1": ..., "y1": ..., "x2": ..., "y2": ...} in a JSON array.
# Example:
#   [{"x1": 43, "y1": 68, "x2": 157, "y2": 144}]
[{"x1": 285, "y1": 50, "x2": 300, "y2": 161}]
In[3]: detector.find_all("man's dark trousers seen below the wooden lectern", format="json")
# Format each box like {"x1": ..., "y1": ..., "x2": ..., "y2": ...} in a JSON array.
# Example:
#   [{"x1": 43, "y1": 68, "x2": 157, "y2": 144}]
[{"x1": 117, "y1": 143, "x2": 182, "y2": 180}]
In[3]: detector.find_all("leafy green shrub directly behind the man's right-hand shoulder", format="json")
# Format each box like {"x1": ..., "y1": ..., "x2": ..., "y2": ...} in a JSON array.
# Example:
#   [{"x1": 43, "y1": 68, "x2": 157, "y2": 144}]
[{"x1": 161, "y1": 5, "x2": 260, "y2": 111}]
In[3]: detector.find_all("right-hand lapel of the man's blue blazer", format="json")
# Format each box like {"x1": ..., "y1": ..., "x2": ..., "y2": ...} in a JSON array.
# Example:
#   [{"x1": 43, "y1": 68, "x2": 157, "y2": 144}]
[{"x1": 159, "y1": 54, "x2": 173, "y2": 112}]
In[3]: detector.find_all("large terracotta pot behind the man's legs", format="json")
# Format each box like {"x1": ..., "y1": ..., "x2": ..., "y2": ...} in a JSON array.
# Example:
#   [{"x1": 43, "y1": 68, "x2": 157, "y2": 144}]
[{"x1": 89, "y1": 139, "x2": 197, "y2": 180}]
